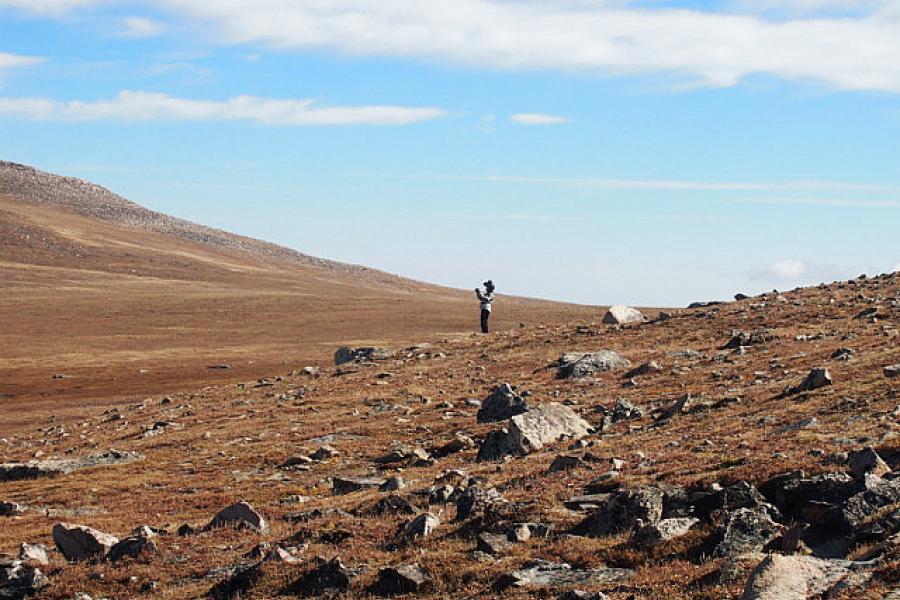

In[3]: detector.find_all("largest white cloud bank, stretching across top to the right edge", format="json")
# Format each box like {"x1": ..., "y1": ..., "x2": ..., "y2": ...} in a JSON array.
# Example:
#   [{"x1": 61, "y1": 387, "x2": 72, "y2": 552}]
[{"x1": 163, "y1": 0, "x2": 900, "y2": 92}]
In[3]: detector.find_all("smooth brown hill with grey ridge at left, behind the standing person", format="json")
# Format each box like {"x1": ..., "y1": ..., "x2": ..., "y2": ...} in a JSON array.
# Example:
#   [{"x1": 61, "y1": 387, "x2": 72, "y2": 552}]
[{"x1": 0, "y1": 162, "x2": 594, "y2": 426}]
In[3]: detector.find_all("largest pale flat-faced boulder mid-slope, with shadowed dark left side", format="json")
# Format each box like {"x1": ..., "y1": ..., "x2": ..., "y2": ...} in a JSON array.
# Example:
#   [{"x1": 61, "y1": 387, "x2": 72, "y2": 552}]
[{"x1": 477, "y1": 402, "x2": 592, "y2": 461}]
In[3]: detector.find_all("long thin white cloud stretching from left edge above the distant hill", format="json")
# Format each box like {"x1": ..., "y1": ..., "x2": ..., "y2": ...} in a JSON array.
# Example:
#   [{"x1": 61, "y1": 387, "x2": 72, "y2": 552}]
[{"x1": 0, "y1": 90, "x2": 446, "y2": 125}]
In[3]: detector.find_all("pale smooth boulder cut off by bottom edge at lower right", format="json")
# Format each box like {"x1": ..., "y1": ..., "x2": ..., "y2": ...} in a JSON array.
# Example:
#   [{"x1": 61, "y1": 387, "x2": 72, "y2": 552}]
[{"x1": 741, "y1": 554, "x2": 852, "y2": 600}]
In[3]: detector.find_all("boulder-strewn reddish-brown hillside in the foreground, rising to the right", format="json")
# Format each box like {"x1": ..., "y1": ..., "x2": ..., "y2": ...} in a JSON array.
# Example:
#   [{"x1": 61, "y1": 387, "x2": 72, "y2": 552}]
[{"x1": 0, "y1": 274, "x2": 900, "y2": 600}]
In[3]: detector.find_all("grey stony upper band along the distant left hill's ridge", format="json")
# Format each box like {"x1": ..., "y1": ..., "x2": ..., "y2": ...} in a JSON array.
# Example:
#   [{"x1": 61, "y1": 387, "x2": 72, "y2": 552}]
[{"x1": 0, "y1": 161, "x2": 400, "y2": 283}]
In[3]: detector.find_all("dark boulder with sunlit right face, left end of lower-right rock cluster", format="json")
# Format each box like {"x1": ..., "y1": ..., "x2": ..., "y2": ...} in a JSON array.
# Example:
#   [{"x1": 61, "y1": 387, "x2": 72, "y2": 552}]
[{"x1": 576, "y1": 486, "x2": 664, "y2": 536}]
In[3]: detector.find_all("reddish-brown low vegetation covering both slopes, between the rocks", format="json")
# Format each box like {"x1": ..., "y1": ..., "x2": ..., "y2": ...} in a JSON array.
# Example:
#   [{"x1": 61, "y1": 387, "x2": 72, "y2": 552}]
[{"x1": 0, "y1": 171, "x2": 900, "y2": 600}]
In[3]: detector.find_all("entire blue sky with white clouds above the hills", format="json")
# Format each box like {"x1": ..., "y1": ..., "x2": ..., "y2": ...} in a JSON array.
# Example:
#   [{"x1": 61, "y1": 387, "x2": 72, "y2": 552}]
[{"x1": 0, "y1": 0, "x2": 900, "y2": 305}]
